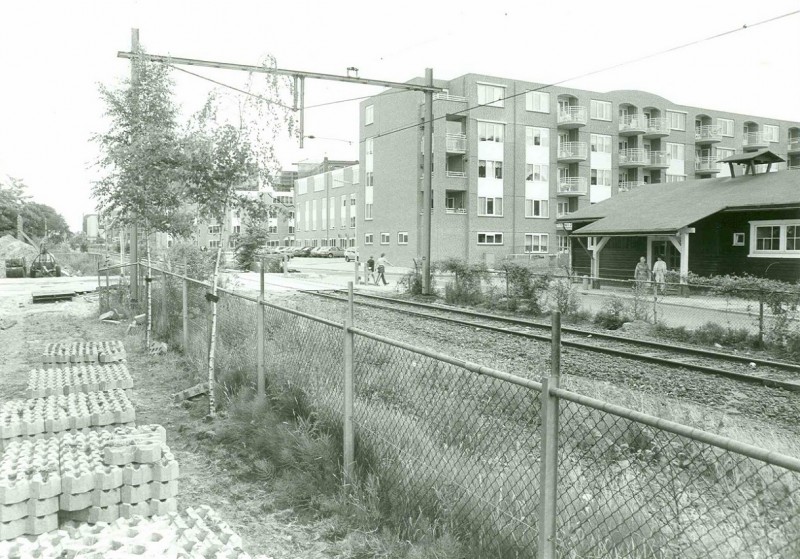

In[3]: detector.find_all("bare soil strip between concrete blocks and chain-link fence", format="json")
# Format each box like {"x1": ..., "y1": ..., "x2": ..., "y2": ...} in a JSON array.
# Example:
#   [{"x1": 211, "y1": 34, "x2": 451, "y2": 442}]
[{"x1": 0, "y1": 286, "x2": 339, "y2": 559}]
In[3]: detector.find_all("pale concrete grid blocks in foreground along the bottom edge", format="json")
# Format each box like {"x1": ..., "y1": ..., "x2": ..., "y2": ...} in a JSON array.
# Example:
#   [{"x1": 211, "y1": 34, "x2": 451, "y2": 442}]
[{"x1": 0, "y1": 507, "x2": 250, "y2": 559}]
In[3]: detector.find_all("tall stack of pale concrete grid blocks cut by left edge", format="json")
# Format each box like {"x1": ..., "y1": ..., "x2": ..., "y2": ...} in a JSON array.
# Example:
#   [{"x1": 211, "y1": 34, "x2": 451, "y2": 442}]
[{"x1": 0, "y1": 438, "x2": 61, "y2": 540}]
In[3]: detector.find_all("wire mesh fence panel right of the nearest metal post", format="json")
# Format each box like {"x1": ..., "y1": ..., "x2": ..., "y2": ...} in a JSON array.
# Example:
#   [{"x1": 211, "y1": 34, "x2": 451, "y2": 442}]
[{"x1": 557, "y1": 400, "x2": 800, "y2": 559}]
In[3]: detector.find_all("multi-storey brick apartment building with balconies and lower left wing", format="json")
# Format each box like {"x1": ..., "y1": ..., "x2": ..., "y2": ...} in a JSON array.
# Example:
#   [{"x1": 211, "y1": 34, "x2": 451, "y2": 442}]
[{"x1": 346, "y1": 74, "x2": 800, "y2": 265}]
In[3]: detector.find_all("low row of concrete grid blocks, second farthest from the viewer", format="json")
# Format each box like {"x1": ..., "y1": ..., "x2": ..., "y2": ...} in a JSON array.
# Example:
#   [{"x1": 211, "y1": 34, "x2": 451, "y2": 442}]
[{"x1": 25, "y1": 363, "x2": 133, "y2": 398}]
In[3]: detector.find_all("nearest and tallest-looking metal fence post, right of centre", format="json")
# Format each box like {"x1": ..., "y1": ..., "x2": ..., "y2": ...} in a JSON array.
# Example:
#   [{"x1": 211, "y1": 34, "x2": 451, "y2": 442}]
[{"x1": 537, "y1": 311, "x2": 561, "y2": 559}]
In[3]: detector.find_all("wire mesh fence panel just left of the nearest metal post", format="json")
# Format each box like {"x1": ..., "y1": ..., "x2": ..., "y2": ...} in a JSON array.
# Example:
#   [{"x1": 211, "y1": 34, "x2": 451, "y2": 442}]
[{"x1": 353, "y1": 337, "x2": 540, "y2": 557}]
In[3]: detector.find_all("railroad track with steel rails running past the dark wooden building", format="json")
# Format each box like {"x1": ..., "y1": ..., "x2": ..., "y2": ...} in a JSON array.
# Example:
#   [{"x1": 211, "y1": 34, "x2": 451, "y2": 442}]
[{"x1": 303, "y1": 291, "x2": 800, "y2": 392}]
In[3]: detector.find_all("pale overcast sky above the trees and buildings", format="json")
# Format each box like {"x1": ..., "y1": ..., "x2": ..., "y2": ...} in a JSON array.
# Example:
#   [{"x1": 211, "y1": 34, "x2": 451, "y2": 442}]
[{"x1": 0, "y1": 0, "x2": 800, "y2": 230}]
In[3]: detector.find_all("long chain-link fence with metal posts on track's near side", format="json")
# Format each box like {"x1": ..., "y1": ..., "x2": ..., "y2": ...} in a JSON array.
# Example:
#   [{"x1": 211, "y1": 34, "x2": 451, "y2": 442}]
[{"x1": 101, "y1": 264, "x2": 800, "y2": 559}]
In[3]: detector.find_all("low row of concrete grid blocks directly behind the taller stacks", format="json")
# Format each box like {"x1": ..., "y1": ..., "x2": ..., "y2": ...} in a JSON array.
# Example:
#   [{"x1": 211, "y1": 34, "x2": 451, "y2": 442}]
[{"x1": 0, "y1": 394, "x2": 136, "y2": 449}]
